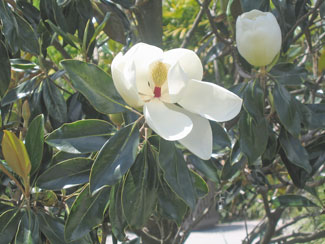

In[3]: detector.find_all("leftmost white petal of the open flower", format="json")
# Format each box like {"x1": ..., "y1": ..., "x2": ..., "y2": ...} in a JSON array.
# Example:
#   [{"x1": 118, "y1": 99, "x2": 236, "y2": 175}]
[{"x1": 111, "y1": 53, "x2": 143, "y2": 107}]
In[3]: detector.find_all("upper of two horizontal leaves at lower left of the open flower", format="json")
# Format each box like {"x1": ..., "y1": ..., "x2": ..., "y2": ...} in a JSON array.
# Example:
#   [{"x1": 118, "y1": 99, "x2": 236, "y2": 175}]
[{"x1": 46, "y1": 119, "x2": 113, "y2": 153}]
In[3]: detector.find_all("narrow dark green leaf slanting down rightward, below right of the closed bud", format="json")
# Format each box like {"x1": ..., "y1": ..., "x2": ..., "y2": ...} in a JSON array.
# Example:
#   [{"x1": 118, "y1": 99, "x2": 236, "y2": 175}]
[{"x1": 273, "y1": 84, "x2": 300, "y2": 136}]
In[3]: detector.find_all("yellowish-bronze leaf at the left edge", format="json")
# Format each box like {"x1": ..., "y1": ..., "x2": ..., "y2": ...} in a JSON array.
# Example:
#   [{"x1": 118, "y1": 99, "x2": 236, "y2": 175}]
[{"x1": 1, "y1": 130, "x2": 31, "y2": 180}]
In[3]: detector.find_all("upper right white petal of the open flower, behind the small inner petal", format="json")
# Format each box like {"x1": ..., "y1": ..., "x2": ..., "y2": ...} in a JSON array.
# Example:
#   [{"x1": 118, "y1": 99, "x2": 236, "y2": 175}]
[{"x1": 163, "y1": 48, "x2": 203, "y2": 80}]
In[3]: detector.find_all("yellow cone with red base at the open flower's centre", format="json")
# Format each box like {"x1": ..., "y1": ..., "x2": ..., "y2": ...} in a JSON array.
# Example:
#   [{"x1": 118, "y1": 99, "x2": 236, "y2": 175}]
[{"x1": 151, "y1": 61, "x2": 168, "y2": 97}]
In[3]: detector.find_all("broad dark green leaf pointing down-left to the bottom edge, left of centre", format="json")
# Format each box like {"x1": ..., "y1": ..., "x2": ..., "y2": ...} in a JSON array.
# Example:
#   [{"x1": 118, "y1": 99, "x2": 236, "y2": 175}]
[{"x1": 64, "y1": 186, "x2": 111, "y2": 241}]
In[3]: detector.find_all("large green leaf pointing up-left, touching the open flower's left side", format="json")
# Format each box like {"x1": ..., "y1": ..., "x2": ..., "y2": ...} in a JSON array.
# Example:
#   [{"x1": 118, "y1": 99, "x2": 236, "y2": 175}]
[{"x1": 61, "y1": 60, "x2": 125, "y2": 114}]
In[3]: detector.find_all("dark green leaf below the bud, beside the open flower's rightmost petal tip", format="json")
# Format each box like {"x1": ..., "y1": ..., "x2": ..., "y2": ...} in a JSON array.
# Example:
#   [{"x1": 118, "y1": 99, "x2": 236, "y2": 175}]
[{"x1": 243, "y1": 81, "x2": 264, "y2": 122}]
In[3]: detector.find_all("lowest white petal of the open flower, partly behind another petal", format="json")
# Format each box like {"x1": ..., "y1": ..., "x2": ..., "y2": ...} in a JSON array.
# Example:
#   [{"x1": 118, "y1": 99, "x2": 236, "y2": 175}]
[{"x1": 168, "y1": 104, "x2": 213, "y2": 160}]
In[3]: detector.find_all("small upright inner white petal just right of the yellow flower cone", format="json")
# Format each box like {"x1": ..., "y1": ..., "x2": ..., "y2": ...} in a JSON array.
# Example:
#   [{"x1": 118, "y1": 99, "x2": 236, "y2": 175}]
[{"x1": 161, "y1": 62, "x2": 188, "y2": 103}]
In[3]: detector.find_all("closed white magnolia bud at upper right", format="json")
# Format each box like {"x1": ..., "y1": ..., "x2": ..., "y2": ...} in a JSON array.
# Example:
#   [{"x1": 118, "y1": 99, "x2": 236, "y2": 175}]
[{"x1": 236, "y1": 9, "x2": 282, "y2": 66}]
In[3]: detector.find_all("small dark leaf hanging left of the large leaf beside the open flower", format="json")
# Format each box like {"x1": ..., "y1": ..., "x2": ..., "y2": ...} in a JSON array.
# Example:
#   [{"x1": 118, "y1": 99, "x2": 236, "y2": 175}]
[{"x1": 43, "y1": 79, "x2": 67, "y2": 123}]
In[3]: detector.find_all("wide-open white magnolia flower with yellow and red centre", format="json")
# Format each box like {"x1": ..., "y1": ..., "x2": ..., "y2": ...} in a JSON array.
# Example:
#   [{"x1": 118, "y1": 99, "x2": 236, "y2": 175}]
[{"x1": 112, "y1": 43, "x2": 242, "y2": 159}]
